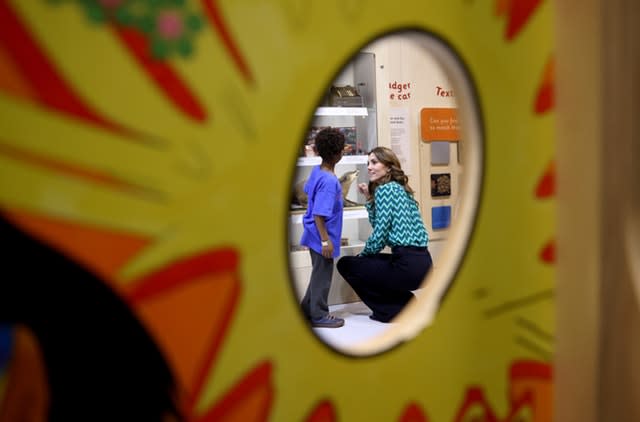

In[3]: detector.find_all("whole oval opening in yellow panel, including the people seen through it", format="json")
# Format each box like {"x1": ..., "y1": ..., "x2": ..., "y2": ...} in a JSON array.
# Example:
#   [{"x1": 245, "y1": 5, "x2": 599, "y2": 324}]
[{"x1": 288, "y1": 31, "x2": 483, "y2": 356}]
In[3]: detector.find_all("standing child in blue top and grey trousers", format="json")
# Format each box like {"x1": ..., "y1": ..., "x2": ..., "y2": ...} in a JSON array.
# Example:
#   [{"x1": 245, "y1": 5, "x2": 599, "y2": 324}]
[{"x1": 300, "y1": 128, "x2": 345, "y2": 328}]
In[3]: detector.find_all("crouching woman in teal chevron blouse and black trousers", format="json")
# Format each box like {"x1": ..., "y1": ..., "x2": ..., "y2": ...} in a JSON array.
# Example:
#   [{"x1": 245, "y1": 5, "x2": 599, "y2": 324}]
[{"x1": 337, "y1": 147, "x2": 432, "y2": 322}]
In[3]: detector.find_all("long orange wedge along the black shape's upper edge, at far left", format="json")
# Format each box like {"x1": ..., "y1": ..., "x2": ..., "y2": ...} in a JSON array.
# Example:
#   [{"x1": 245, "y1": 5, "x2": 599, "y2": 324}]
[{"x1": 6, "y1": 210, "x2": 149, "y2": 288}]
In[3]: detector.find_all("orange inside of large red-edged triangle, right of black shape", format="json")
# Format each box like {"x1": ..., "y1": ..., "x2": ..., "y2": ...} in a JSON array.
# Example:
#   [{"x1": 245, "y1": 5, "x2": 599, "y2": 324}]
[{"x1": 134, "y1": 271, "x2": 239, "y2": 402}]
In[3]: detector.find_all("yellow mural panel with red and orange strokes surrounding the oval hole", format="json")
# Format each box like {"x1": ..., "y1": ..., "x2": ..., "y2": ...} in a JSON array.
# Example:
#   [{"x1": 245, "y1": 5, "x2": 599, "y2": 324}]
[{"x1": 0, "y1": 0, "x2": 554, "y2": 422}]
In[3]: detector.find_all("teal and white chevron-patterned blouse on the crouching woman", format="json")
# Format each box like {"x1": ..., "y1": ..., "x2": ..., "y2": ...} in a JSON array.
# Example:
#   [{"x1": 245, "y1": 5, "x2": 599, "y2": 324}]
[{"x1": 360, "y1": 182, "x2": 429, "y2": 255}]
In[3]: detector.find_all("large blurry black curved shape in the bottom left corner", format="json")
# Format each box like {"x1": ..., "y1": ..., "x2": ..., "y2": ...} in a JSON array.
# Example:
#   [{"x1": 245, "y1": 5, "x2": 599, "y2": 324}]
[{"x1": 0, "y1": 214, "x2": 183, "y2": 422}]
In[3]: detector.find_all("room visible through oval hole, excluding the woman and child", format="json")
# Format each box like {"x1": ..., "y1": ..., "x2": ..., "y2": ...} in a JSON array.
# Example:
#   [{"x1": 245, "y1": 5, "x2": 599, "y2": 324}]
[{"x1": 288, "y1": 30, "x2": 483, "y2": 356}]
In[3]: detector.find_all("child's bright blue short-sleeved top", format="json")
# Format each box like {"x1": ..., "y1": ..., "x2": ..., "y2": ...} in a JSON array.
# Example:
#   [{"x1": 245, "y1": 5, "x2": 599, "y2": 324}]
[{"x1": 300, "y1": 166, "x2": 344, "y2": 258}]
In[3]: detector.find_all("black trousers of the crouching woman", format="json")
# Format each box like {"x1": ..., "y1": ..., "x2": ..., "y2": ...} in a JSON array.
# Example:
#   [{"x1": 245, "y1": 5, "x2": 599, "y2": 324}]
[{"x1": 337, "y1": 246, "x2": 432, "y2": 322}]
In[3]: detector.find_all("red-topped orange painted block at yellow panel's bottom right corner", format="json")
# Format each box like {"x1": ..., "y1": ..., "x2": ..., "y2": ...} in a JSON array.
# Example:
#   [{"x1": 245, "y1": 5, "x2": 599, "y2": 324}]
[{"x1": 509, "y1": 361, "x2": 553, "y2": 422}]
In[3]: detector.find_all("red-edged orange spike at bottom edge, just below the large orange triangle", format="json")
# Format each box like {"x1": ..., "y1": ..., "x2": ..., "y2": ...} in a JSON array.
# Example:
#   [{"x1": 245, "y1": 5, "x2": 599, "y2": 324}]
[{"x1": 192, "y1": 362, "x2": 274, "y2": 422}]
